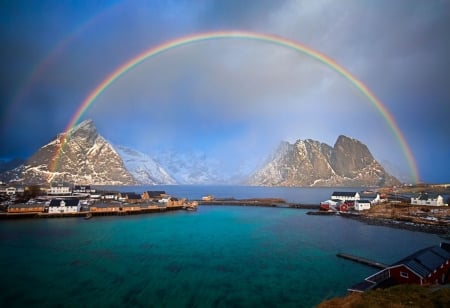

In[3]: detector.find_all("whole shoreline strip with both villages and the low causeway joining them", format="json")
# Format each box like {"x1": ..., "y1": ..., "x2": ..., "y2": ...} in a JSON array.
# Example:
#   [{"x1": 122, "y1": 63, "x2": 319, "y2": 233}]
[{"x1": 0, "y1": 182, "x2": 450, "y2": 225}]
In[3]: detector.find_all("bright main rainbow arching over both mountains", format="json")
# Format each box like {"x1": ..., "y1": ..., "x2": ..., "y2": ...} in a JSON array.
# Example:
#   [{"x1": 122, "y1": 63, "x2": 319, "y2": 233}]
[{"x1": 50, "y1": 31, "x2": 419, "y2": 183}]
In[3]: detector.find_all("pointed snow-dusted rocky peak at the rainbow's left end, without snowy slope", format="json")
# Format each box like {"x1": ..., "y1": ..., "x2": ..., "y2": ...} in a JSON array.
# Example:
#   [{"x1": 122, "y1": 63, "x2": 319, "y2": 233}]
[{"x1": 14, "y1": 120, "x2": 137, "y2": 185}]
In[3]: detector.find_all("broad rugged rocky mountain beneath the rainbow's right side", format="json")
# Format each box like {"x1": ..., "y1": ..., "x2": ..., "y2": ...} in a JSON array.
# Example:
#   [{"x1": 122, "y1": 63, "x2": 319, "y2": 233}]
[{"x1": 248, "y1": 136, "x2": 399, "y2": 186}]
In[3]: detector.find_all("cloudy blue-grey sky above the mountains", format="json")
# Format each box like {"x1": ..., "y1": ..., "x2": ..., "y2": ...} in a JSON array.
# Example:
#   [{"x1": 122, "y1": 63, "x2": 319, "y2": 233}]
[{"x1": 0, "y1": 0, "x2": 450, "y2": 183}]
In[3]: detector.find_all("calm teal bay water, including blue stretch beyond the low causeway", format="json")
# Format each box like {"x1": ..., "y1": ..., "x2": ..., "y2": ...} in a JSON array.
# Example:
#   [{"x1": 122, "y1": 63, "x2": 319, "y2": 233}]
[{"x1": 0, "y1": 186, "x2": 440, "y2": 307}]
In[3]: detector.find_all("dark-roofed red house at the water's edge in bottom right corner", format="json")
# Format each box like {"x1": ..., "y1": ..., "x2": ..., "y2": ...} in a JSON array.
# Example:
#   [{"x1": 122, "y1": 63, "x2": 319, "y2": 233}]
[{"x1": 348, "y1": 243, "x2": 450, "y2": 292}]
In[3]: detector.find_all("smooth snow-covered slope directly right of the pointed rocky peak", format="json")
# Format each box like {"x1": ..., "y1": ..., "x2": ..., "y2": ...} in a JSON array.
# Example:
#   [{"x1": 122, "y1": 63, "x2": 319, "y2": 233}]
[{"x1": 114, "y1": 145, "x2": 177, "y2": 185}]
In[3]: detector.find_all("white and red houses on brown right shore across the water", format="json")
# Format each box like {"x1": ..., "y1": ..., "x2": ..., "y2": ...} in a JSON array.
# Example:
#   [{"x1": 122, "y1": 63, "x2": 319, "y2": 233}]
[{"x1": 316, "y1": 189, "x2": 450, "y2": 238}]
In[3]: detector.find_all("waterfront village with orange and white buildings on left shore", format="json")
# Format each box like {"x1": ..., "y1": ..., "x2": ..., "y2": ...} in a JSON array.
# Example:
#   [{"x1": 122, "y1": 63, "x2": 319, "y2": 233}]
[{"x1": 0, "y1": 184, "x2": 198, "y2": 218}]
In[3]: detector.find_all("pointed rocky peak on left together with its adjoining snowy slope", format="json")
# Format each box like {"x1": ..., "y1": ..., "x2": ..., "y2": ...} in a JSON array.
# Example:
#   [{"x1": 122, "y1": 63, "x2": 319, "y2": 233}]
[{"x1": 1, "y1": 120, "x2": 176, "y2": 185}]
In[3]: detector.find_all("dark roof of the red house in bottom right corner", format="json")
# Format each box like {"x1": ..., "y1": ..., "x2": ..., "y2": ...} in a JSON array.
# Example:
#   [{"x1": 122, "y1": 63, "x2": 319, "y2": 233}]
[{"x1": 391, "y1": 246, "x2": 450, "y2": 277}]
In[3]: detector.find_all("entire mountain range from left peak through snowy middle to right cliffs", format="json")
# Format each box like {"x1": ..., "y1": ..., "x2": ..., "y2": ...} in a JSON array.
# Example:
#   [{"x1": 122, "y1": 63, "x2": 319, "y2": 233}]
[{"x1": 1, "y1": 120, "x2": 399, "y2": 186}]
